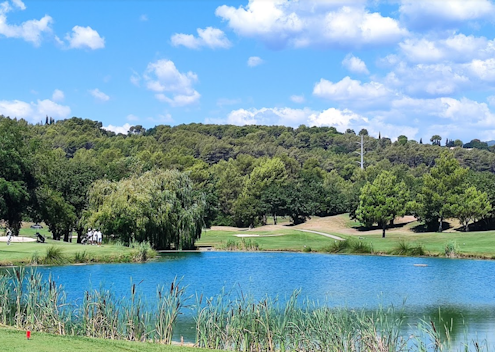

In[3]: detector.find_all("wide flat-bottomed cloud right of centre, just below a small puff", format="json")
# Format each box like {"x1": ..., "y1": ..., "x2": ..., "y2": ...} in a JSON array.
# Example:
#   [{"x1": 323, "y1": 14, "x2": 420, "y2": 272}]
[{"x1": 313, "y1": 76, "x2": 395, "y2": 104}]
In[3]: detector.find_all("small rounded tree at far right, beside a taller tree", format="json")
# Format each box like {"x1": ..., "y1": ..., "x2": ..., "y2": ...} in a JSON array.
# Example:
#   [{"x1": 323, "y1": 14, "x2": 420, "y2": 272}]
[{"x1": 455, "y1": 186, "x2": 492, "y2": 231}]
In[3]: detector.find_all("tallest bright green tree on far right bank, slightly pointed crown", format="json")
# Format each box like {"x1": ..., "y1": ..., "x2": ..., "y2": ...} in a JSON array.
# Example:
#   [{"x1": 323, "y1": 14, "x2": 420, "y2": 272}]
[{"x1": 415, "y1": 151, "x2": 467, "y2": 232}]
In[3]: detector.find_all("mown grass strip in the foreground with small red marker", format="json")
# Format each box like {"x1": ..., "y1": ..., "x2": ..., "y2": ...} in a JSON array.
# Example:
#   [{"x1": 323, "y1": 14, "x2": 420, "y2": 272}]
[{"x1": 0, "y1": 327, "x2": 213, "y2": 352}]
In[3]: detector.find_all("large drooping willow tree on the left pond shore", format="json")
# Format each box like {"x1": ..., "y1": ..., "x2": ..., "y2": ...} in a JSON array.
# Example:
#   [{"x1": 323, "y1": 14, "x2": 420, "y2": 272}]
[{"x1": 88, "y1": 170, "x2": 205, "y2": 249}]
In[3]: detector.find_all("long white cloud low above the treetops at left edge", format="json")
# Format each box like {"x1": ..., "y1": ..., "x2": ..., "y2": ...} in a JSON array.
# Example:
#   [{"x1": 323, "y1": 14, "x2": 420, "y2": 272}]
[{"x1": 0, "y1": 99, "x2": 71, "y2": 122}]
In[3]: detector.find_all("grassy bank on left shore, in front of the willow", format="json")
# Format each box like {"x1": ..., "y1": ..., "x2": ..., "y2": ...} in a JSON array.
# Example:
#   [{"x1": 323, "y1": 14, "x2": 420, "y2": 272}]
[{"x1": 0, "y1": 225, "x2": 157, "y2": 266}]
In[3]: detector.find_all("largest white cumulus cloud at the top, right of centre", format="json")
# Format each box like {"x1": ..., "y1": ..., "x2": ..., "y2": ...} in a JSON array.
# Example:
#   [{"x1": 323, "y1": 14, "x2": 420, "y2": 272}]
[{"x1": 215, "y1": 0, "x2": 407, "y2": 49}]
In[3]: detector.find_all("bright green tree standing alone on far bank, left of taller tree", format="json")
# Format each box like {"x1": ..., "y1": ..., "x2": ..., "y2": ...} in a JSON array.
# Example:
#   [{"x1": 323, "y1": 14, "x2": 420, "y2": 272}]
[{"x1": 356, "y1": 171, "x2": 409, "y2": 237}]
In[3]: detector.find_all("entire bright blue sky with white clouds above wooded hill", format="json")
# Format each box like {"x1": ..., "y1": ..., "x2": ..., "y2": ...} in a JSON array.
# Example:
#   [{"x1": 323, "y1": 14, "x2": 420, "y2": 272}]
[{"x1": 0, "y1": 0, "x2": 495, "y2": 143}]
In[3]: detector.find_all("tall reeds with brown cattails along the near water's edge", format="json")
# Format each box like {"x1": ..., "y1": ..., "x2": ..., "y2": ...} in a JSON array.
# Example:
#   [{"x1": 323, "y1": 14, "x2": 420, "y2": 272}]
[{"x1": 0, "y1": 268, "x2": 495, "y2": 352}]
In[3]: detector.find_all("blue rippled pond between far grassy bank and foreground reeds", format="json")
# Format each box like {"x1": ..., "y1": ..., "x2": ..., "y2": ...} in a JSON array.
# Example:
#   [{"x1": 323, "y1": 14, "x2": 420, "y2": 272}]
[{"x1": 40, "y1": 252, "x2": 495, "y2": 344}]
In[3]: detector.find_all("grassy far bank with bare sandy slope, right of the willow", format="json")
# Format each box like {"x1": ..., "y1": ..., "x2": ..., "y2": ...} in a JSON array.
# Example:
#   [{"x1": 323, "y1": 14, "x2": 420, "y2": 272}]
[{"x1": 197, "y1": 214, "x2": 495, "y2": 259}]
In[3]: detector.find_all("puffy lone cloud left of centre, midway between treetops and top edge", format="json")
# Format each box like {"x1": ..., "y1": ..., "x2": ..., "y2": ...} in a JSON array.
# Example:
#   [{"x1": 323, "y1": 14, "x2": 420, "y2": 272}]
[{"x1": 143, "y1": 60, "x2": 201, "y2": 106}]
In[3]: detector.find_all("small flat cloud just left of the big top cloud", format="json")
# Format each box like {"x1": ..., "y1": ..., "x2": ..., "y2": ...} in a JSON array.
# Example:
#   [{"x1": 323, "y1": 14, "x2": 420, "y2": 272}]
[{"x1": 170, "y1": 27, "x2": 232, "y2": 49}]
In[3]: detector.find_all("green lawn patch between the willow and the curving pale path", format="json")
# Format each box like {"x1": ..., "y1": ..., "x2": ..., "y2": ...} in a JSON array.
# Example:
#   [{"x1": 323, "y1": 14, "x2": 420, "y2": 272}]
[{"x1": 196, "y1": 229, "x2": 334, "y2": 251}]
